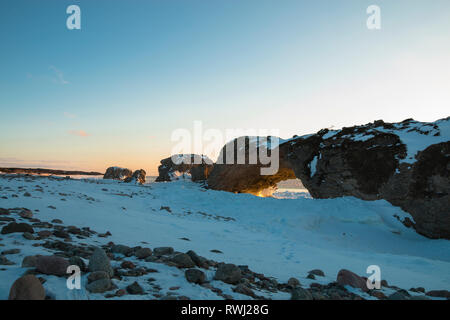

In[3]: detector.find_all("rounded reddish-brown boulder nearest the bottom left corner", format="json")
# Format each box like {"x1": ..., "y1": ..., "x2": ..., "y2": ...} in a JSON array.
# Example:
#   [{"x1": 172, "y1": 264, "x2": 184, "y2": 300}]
[{"x1": 8, "y1": 274, "x2": 45, "y2": 300}]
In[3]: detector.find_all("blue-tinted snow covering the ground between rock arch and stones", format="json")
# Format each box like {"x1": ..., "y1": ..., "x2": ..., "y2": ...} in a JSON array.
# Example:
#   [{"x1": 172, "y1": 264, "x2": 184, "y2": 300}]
[{"x1": 0, "y1": 177, "x2": 450, "y2": 299}]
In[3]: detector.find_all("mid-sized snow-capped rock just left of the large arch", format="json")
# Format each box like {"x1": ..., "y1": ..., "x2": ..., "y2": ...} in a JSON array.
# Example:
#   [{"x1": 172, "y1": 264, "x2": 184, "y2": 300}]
[{"x1": 156, "y1": 154, "x2": 213, "y2": 182}]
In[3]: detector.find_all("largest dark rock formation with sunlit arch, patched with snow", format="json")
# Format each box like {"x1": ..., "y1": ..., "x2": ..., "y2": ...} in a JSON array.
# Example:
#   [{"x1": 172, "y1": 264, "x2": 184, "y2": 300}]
[{"x1": 207, "y1": 117, "x2": 450, "y2": 239}]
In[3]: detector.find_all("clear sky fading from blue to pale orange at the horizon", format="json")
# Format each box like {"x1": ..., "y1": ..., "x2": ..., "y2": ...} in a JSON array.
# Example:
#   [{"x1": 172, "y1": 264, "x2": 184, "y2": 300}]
[{"x1": 0, "y1": 0, "x2": 450, "y2": 173}]
